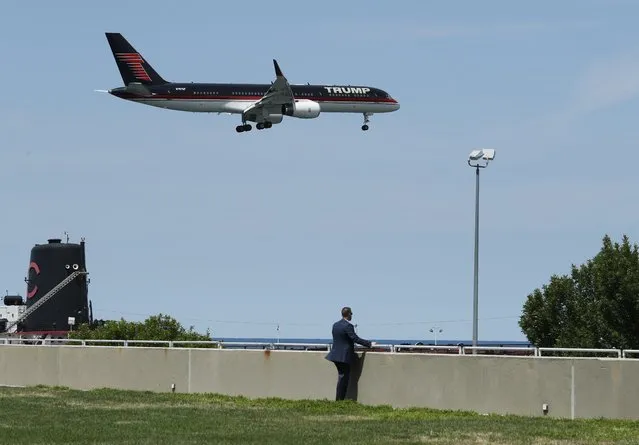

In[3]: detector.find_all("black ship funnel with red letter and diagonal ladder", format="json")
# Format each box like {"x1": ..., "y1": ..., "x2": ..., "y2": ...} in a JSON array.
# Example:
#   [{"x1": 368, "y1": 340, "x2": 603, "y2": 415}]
[{"x1": 23, "y1": 238, "x2": 90, "y2": 331}]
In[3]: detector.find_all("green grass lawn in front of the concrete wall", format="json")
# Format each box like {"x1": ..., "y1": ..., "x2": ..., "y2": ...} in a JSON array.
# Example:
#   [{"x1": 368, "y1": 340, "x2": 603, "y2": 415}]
[{"x1": 0, "y1": 387, "x2": 639, "y2": 445}]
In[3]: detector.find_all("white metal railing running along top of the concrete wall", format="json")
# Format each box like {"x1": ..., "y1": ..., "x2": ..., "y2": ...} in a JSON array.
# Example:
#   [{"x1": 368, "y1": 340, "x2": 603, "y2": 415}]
[{"x1": 0, "y1": 337, "x2": 639, "y2": 360}]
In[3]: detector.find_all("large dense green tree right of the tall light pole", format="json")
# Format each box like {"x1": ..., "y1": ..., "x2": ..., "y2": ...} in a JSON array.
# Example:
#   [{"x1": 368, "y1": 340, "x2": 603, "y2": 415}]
[{"x1": 519, "y1": 235, "x2": 639, "y2": 349}]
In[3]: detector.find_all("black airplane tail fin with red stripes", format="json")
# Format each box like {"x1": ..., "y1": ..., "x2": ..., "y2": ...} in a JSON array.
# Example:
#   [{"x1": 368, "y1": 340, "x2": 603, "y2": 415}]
[{"x1": 105, "y1": 32, "x2": 167, "y2": 85}]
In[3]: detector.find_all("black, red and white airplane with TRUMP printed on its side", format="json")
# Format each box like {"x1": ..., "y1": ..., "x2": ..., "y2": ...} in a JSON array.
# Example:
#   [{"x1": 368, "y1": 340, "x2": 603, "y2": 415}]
[{"x1": 102, "y1": 32, "x2": 399, "y2": 133}]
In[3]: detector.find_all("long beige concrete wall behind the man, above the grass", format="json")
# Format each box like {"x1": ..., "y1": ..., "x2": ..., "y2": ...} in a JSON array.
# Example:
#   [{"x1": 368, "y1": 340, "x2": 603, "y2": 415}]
[{"x1": 0, "y1": 345, "x2": 639, "y2": 419}]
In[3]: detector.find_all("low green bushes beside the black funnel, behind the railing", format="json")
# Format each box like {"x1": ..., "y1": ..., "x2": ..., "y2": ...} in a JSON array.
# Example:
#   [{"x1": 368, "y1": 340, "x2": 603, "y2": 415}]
[{"x1": 69, "y1": 314, "x2": 211, "y2": 347}]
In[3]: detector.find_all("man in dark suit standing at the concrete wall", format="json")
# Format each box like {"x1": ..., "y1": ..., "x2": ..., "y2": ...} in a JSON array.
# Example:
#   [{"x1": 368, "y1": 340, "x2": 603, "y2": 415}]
[{"x1": 326, "y1": 307, "x2": 374, "y2": 400}]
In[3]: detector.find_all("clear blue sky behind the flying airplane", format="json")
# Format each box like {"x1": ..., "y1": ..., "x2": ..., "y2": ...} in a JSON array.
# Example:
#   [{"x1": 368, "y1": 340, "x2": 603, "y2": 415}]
[{"x1": 0, "y1": 0, "x2": 639, "y2": 340}]
